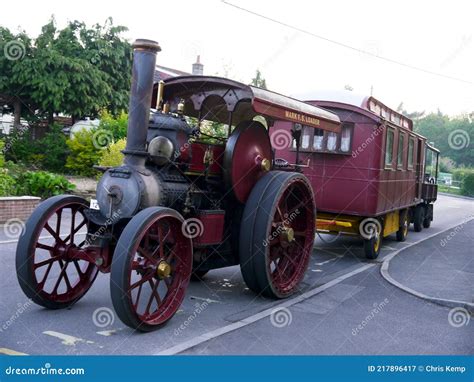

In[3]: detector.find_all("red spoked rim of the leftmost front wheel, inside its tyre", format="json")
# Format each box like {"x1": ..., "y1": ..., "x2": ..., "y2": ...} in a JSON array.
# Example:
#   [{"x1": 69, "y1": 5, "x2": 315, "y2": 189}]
[{"x1": 30, "y1": 202, "x2": 98, "y2": 303}]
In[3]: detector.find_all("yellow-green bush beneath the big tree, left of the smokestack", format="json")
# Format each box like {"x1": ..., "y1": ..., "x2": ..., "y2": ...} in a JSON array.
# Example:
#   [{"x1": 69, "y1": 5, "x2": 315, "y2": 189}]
[{"x1": 66, "y1": 130, "x2": 102, "y2": 176}]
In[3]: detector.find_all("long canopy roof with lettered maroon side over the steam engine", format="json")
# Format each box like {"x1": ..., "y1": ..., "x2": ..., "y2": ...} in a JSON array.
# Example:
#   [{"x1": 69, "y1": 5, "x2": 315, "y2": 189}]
[{"x1": 163, "y1": 76, "x2": 341, "y2": 132}]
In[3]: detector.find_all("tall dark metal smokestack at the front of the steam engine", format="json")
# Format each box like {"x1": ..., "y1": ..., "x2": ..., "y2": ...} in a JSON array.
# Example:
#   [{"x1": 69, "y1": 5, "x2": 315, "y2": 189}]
[{"x1": 123, "y1": 39, "x2": 161, "y2": 166}]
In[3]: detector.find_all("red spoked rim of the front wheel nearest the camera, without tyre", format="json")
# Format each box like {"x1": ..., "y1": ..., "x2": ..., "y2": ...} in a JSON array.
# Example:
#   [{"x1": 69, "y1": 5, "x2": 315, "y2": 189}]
[{"x1": 127, "y1": 215, "x2": 192, "y2": 325}]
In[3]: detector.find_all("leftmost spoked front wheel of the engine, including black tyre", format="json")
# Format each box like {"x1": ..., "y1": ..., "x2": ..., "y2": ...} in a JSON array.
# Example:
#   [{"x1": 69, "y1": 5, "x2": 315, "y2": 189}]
[{"x1": 16, "y1": 195, "x2": 98, "y2": 309}]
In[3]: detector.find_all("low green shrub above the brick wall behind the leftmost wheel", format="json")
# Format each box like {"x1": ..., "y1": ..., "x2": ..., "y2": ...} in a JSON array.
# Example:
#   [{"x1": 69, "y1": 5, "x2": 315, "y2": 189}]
[{"x1": 17, "y1": 171, "x2": 75, "y2": 199}]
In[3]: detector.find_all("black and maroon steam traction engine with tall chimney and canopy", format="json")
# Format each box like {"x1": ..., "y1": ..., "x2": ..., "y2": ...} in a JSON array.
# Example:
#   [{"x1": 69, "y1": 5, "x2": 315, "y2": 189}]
[{"x1": 16, "y1": 40, "x2": 339, "y2": 331}]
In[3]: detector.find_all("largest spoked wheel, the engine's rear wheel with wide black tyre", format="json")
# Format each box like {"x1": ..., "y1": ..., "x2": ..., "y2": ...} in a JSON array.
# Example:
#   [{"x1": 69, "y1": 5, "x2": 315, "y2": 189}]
[{"x1": 239, "y1": 171, "x2": 315, "y2": 298}]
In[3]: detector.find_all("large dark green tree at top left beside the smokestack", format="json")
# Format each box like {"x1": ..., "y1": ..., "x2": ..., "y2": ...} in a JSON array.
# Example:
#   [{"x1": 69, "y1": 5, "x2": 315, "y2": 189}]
[{"x1": 0, "y1": 19, "x2": 131, "y2": 120}]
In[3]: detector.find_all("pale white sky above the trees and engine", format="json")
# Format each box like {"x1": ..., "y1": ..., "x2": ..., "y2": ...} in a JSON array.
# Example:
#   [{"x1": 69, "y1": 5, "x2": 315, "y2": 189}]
[{"x1": 0, "y1": 0, "x2": 474, "y2": 116}]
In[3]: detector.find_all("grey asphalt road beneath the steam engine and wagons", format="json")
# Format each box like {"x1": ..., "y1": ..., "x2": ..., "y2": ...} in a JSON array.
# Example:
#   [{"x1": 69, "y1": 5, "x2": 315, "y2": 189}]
[{"x1": 0, "y1": 195, "x2": 474, "y2": 355}]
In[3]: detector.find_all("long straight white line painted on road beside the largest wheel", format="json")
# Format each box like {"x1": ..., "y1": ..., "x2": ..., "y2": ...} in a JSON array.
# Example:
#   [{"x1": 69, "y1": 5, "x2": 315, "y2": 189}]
[{"x1": 156, "y1": 264, "x2": 376, "y2": 355}]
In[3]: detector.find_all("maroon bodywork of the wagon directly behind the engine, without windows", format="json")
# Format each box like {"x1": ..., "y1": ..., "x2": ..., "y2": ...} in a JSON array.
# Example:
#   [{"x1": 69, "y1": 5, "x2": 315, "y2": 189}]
[{"x1": 274, "y1": 97, "x2": 432, "y2": 216}]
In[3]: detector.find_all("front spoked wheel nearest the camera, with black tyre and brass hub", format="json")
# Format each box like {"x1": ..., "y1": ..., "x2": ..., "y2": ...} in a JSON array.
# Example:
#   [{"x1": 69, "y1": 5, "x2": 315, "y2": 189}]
[{"x1": 110, "y1": 207, "x2": 193, "y2": 332}]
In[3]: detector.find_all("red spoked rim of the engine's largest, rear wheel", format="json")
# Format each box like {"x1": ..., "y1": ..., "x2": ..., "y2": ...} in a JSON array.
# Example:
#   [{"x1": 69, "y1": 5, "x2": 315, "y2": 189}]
[{"x1": 266, "y1": 180, "x2": 315, "y2": 296}]
